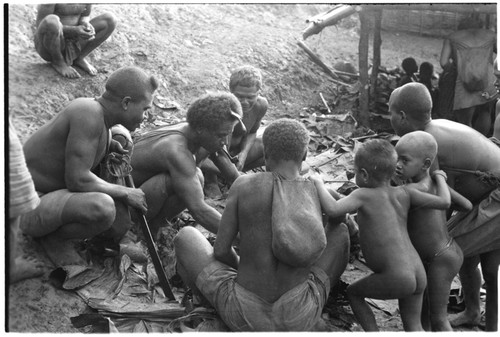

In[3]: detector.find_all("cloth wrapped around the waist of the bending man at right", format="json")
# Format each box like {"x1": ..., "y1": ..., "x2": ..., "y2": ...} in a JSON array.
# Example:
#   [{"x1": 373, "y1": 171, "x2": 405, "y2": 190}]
[{"x1": 447, "y1": 187, "x2": 500, "y2": 257}]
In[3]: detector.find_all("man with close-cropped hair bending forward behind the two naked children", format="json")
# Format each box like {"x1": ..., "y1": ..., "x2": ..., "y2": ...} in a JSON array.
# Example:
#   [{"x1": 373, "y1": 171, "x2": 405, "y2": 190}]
[{"x1": 389, "y1": 83, "x2": 500, "y2": 331}]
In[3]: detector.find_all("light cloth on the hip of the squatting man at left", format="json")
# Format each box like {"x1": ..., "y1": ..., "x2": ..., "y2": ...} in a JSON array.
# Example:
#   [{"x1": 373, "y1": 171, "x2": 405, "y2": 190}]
[{"x1": 21, "y1": 189, "x2": 76, "y2": 237}]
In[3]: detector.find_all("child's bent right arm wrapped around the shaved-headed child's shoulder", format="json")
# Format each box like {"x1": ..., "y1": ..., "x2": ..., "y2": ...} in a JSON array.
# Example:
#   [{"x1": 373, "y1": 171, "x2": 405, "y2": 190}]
[{"x1": 407, "y1": 170, "x2": 451, "y2": 209}]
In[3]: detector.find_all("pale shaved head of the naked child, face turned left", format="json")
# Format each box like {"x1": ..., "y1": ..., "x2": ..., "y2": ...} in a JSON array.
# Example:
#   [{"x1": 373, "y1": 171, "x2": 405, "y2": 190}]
[{"x1": 396, "y1": 131, "x2": 438, "y2": 181}]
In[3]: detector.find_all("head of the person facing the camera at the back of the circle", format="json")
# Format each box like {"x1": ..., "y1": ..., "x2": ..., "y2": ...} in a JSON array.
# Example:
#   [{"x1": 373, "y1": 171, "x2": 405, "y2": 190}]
[{"x1": 229, "y1": 66, "x2": 262, "y2": 111}]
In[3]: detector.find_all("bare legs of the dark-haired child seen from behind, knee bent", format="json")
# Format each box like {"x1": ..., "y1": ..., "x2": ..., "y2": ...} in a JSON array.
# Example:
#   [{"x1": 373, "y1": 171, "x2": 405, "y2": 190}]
[{"x1": 347, "y1": 267, "x2": 426, "y2": 331}]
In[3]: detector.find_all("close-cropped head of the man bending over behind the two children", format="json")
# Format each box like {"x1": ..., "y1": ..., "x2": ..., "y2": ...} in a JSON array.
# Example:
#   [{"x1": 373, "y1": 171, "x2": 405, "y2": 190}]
[{"x1": 389, "y1": 82, "x2": 432, "y2": 136}]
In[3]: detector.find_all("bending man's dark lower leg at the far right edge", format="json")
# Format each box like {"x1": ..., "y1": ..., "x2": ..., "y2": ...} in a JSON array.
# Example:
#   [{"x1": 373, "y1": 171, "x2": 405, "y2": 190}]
[{"x1": 481, "y1": 250, "x2": 500, "y2": 331}]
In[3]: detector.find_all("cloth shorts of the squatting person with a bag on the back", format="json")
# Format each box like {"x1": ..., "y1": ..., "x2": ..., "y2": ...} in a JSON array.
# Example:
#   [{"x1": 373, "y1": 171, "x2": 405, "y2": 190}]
[{"x1": 196, "y1": 261, "x2": 330, "y2": 331}]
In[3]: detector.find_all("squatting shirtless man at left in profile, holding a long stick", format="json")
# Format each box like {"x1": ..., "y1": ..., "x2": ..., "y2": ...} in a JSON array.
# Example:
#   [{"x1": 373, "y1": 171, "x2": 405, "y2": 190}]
[{"x1": 21, "y1": 67, "x2": 158, "y2": 265}]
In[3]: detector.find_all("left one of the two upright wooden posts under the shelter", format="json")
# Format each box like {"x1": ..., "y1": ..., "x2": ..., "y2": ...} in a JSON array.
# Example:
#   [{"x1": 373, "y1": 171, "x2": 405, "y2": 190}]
[{"x1": 356, "y1": 9, "x2": 370, "y2": 127}]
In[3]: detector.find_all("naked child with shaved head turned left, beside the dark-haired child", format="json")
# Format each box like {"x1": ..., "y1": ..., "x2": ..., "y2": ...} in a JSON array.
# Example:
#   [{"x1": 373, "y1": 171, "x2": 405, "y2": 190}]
[{"x1": 396, "y1": 131, "x2": 472, "y2": 331}]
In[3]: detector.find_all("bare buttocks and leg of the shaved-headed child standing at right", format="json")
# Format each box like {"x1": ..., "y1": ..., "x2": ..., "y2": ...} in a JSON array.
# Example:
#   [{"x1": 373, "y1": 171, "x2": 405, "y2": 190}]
[{"x1": 427, "y1": 242, "x2": 463, "y2": 331}]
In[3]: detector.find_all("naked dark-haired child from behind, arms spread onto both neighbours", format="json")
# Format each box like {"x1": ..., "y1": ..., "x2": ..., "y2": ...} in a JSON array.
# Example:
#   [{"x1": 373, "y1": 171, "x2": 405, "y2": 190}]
[{"x1": 311, "y1": 139, "x2": 450, "y2": 331}]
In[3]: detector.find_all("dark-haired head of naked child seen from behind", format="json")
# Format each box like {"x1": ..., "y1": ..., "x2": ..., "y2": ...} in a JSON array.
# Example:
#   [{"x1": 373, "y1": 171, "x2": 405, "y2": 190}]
[{"x1": 354, "y1": 139, "x2": 398, "y2": 187}]
